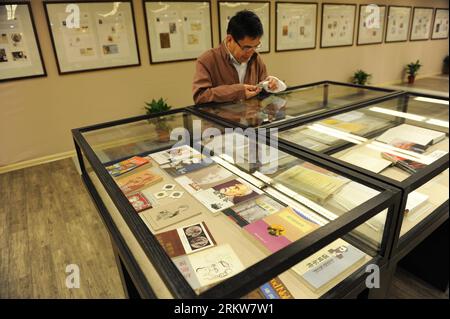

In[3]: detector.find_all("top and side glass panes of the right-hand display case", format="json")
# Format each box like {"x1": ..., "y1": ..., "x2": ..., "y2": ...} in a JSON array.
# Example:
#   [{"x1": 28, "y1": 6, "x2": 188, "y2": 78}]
[{"x1": 278, "y1": 94, "x2": 449, "y2": 240}]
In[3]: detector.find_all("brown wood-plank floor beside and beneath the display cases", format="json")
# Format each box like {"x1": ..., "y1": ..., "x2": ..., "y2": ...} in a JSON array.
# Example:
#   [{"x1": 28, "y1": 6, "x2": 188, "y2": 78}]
[{"x1": 0, "y1": 159, "x2": 449, "y2": 299}]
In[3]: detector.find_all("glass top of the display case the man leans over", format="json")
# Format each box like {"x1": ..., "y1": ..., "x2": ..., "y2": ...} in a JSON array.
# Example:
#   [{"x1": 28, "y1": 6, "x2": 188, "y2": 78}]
[{"x1": 193, "y1": 81, "x2": 399, "y2": 128}]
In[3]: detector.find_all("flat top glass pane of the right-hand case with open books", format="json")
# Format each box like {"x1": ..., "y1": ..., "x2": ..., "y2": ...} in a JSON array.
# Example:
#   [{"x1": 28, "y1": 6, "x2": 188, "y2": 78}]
[{"x1": 279, "y1": 95, "x2": 449, "y2": 182}]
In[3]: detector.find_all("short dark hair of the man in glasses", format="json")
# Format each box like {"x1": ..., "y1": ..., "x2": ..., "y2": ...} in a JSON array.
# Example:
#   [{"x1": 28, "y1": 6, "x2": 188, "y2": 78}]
[{"x1": 227, "y1": 10, "x2": 264, "y2": 41}]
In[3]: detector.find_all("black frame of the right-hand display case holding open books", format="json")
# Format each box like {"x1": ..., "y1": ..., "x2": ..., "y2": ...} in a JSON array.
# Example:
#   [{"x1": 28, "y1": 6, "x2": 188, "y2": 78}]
[{"x1": 270, "y1": 92, "x2": 449, "y2": 291}]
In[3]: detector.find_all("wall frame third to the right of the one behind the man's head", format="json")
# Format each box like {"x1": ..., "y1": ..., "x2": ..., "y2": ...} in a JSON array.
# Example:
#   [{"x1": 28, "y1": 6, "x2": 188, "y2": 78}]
[{"x1": 356, "y1": 4, "x2": 386, "y2": 45}]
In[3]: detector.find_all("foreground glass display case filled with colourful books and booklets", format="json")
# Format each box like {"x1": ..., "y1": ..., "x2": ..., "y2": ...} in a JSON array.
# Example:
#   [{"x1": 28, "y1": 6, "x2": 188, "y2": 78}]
[{"x1": 73, "y1": 109, "x2": 401, "y2": 299}]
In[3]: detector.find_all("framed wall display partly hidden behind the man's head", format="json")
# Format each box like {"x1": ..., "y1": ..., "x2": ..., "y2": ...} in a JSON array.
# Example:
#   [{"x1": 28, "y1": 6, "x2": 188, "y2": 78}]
[{"x1": 218, "y1": 1, "x2": 270, "y2": 53}]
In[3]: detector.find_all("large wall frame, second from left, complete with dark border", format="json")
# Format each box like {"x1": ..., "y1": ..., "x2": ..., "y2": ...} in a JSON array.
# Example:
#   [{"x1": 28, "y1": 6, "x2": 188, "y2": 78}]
[{"x1": 44, "y1": 1, "x2": 140, "y2": 74}]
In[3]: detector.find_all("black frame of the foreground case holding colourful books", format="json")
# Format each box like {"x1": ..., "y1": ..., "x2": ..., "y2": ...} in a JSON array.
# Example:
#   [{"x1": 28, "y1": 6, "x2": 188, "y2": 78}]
[{"x1": 72, "y1": 107, "x2": 401, "y2": 298}]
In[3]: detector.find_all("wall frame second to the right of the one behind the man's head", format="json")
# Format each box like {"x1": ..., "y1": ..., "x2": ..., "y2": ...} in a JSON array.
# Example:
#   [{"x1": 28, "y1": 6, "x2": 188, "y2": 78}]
[{"x1": 320, "y1": 3, "x2": 356, "y2": 48}]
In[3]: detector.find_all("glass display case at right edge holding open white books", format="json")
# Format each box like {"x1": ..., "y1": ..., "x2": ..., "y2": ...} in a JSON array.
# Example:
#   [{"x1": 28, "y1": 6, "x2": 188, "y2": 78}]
[{"x1": 278, "y1": 93, "x2": 449, "y2": 290}]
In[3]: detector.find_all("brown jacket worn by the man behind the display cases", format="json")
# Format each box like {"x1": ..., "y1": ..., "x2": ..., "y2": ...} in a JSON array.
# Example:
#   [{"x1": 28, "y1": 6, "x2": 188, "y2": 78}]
[{"x1": 192, "y1": 42, "x2": 267, "y2": 104}]
